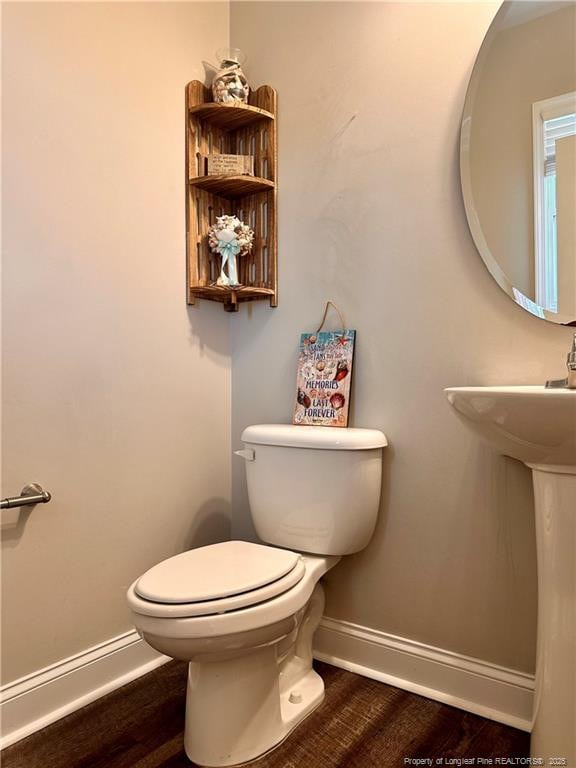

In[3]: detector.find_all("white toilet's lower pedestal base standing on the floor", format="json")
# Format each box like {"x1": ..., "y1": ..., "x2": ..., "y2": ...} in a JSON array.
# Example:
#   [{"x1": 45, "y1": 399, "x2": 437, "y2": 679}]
[{"x1": 184, "y1": 585, "x2": 324, "y2": 768}]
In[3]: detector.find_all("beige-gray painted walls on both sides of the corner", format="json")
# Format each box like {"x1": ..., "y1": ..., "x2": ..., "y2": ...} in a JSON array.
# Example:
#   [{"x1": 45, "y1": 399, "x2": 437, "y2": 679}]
[{"x1": 3, "y1": 2, "x2": 570, "y2": 680}]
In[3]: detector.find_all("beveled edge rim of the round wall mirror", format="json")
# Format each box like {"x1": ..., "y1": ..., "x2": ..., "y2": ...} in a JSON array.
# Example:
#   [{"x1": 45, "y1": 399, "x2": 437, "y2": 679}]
[{"x1": 460, "y1": 0, "x2": 576, "y2": 327}]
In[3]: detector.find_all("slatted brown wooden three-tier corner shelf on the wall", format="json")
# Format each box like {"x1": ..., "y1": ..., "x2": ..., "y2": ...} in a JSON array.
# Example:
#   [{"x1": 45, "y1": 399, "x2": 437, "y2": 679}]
[{"x1": 186, "y1": 80, "x2": 278, "y2": 312}]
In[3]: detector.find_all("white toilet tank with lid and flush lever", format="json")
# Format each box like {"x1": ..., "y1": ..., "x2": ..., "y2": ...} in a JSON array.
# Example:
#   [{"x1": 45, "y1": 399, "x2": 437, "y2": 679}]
[{"x1": 242, "y1": 424, "x2": 387, "y2": 555}]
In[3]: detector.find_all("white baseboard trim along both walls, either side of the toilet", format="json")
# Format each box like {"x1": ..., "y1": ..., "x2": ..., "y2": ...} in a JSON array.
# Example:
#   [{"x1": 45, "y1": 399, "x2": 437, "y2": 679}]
[{"x1": 0, "y1": 618, "x2": 534, "y2": 749}]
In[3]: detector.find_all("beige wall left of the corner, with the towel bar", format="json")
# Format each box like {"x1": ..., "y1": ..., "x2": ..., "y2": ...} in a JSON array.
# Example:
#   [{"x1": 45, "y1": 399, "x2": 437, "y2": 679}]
[{"x1": 2, "y1": 3, "x2": 230, "y2": 681}]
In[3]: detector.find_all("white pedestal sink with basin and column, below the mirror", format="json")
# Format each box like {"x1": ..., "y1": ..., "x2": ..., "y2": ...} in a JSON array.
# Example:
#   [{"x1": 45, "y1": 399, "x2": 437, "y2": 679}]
[{"x1": 445, "y1": 387, "x2": 576, "y2": 768}]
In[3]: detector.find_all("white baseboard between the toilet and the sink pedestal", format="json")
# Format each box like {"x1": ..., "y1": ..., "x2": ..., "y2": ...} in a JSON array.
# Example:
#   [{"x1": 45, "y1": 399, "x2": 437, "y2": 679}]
[{"x1": 314, "y1": 617, "x2": 534, "y2": 731}]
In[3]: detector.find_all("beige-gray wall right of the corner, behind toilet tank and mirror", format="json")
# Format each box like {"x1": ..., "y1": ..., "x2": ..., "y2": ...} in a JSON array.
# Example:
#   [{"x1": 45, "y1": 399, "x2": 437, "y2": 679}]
[{"x1": 231, "y1": 2, "x2": 570, "y2": 670}]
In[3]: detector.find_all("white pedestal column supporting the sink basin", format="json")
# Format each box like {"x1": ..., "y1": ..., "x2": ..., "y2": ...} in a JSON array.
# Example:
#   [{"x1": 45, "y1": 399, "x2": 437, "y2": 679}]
[{"x1": 528, "y1": 464, "x2": 576, "y2": 768}]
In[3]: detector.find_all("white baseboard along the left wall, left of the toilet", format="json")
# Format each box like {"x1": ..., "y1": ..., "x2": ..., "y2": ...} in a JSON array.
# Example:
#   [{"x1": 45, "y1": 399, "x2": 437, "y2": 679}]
[{"x1": 0, "y1": 630, "x2": 170, "y2": 749}]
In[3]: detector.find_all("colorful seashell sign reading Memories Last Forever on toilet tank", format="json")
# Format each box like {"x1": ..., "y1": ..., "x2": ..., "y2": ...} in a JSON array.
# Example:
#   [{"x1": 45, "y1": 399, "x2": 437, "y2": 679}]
[{"x1": 292, "y1": 302, "x2": 356, "y2": 427}]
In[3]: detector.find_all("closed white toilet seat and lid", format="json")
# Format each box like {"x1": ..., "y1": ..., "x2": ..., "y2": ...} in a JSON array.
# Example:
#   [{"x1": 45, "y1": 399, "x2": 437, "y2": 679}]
[{"x1": 129, "y1": 541, "x2": 306, "y2": 618}]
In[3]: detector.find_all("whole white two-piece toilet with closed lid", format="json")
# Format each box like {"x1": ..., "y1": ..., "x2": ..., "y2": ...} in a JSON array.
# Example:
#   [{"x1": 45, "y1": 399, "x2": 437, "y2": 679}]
[{"x1": 128, "y1": 424, "x2": 387, "y2": 766}]
